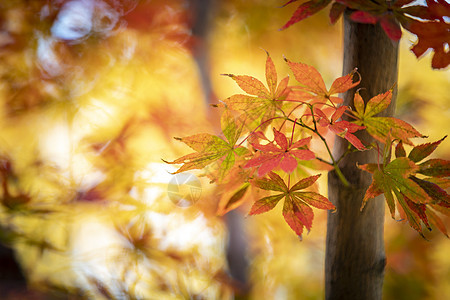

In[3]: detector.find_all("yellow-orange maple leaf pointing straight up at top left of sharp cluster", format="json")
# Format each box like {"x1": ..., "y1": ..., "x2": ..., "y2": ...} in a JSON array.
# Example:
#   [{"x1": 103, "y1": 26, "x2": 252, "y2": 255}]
[{"x1": 217, "y1": 53, "x2": 289, "y2": 129}]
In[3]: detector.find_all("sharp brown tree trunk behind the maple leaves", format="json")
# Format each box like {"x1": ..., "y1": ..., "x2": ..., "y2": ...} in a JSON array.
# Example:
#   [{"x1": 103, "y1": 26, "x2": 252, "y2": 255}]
[{"x1": 325, "y1": 11, "x2": 398, "y2": 300}]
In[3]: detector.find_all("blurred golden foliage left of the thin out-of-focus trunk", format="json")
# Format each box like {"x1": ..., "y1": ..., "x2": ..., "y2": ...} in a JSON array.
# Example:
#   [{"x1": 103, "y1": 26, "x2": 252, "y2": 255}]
[{"x1": 0, "y1": 0, "x2": 229, "y2": 299}]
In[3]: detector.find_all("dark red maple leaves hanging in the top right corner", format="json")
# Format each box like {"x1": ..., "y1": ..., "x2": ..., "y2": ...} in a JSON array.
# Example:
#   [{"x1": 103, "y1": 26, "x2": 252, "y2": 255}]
[{"x1": 282, "y1": 0, "x2": 450, "y2": 69}]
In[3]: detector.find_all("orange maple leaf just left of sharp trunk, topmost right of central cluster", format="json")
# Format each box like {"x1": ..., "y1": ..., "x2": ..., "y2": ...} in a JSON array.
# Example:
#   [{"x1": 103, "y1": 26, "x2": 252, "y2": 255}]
[{"x1": 285, "y1": 58, "x2": 361, "y2": 105}]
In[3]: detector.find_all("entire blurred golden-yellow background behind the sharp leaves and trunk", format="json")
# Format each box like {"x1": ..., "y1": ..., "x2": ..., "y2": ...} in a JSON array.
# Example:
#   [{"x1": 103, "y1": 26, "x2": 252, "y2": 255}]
[{"x1": 0, "y1": 0, "x2": 450, "y2": 300}]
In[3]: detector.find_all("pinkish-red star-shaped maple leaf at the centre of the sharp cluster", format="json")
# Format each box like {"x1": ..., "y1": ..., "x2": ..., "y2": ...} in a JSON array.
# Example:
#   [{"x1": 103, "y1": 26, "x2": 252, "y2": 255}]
[{"x1": 244, "y1": 128, "x2": 316, "y2": 176}]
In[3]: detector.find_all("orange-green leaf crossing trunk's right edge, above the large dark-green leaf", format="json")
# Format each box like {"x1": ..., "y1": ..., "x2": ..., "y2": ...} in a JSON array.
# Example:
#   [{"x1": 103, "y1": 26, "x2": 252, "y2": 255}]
[{"x1": 352, "y1": 90, "x2": 425, "y2": 145}]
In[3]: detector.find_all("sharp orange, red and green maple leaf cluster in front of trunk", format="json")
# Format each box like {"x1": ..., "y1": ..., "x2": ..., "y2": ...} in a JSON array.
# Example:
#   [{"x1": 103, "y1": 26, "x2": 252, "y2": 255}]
[{"x1": 168, "y1": 54, "x2": 450, "y2": 236}]
